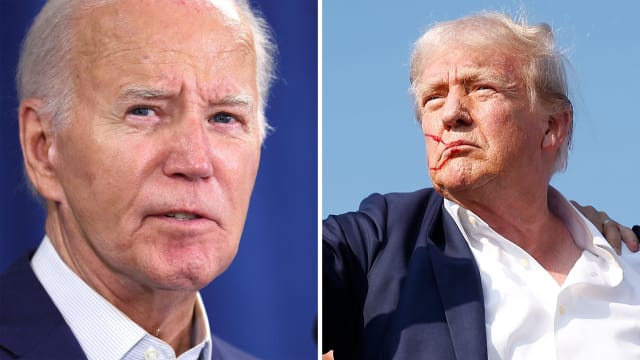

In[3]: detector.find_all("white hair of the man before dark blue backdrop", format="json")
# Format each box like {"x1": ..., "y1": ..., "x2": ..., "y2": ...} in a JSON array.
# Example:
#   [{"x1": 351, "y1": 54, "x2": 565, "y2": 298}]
[{"x1": 16, "y1": 0, "x2": 276, "y2": 140}]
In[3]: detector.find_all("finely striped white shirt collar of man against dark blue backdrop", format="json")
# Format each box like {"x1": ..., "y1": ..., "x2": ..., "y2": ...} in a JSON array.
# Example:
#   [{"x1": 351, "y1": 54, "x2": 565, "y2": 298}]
[{"x1": 31, "y1": 236, "x2": 211, "y2": 360}]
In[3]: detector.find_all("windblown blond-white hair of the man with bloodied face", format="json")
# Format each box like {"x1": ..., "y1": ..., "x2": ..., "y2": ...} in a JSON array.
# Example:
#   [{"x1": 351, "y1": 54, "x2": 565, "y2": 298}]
[{"x1": 410, "y1": 12, "x2": 573, "y2": 173}]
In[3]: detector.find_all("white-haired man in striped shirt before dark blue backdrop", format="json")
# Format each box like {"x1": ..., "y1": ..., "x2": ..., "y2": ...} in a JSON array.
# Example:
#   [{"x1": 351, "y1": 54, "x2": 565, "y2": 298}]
[{"x1": 0, "y1": 0, "x2": 274, "y2": 360}]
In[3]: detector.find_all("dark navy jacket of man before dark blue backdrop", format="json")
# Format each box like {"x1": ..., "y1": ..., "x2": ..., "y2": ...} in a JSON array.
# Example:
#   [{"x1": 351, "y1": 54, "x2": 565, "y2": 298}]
[{"x1": 0, "y1": 254, "x2": 255, "y2": 360}]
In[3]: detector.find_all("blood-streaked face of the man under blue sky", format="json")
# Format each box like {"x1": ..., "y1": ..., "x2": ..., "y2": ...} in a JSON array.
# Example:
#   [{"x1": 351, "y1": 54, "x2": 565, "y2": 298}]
[{"x1": 418, "y1": 44, "x2": 546, "y2": 198}]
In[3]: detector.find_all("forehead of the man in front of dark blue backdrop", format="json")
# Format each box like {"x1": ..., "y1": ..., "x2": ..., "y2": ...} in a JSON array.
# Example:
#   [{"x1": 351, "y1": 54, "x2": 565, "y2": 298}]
[{"x1": 76, "y1": 0, "x2": 254, "y2": 57}]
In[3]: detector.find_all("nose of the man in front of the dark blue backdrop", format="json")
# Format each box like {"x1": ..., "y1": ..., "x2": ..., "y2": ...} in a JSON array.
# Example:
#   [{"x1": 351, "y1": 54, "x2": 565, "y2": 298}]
[{"x1": 163, "y1": 114, "x2": 213, "y2": 180}]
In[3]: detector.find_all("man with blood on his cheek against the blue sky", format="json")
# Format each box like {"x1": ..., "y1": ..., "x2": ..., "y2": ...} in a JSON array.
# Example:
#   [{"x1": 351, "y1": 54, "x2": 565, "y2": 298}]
[{"x1": 322, "y1": 13, "x2": 640, "y2": 360}]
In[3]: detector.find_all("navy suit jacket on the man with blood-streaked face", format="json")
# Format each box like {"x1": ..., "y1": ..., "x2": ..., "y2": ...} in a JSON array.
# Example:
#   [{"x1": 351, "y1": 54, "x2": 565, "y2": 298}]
[{"x1": 322, "y1": 189, "x2": 487, "y2": 360}]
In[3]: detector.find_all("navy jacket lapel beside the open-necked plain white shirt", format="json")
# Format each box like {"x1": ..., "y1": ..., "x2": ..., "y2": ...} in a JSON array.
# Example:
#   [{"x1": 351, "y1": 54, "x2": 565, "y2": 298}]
[{"x1": 427, "y1": 202, "x2": 487, "y2": 360}]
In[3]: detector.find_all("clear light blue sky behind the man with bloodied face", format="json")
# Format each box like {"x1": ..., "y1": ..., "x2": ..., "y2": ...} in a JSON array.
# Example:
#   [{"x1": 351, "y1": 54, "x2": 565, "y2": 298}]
[{"x1": 322, "y1": 0, "x2": 640, "y2": 225}]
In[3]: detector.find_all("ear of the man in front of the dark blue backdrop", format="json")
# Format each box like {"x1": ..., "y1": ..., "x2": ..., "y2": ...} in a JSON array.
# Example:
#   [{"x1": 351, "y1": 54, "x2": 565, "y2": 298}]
[{"x1": 18, "y1": 99, "x2": 62, "y2": 201}]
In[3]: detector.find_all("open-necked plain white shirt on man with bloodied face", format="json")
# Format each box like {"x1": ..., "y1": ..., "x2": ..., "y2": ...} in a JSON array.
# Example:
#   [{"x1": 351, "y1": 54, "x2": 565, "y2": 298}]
[{"x1": 444, "y1": 188, "x2": 640, "y2": 360}]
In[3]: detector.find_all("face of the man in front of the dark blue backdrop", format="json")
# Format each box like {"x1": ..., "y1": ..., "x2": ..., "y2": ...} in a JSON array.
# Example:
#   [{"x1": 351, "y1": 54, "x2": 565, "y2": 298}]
[{"x1": 45, "y1": 0, "x2": 261, "y2": 289}]
